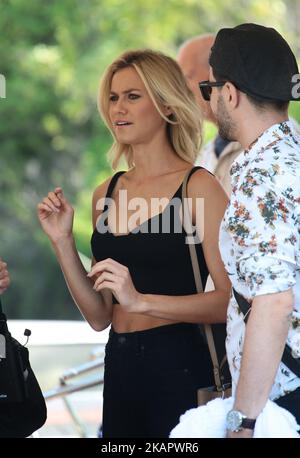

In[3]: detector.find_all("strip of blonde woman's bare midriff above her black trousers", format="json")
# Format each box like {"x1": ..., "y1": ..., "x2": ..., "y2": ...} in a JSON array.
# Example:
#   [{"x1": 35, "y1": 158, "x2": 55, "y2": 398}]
[{"x1": 112, "y1": 304, "x2": 179, "y2": 333}]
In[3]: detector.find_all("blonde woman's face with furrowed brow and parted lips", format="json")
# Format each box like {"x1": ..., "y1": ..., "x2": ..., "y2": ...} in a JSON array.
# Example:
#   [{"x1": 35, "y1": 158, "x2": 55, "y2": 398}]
[{"x1": 109, "y1": 67, "x2": 166, "y2": 145}]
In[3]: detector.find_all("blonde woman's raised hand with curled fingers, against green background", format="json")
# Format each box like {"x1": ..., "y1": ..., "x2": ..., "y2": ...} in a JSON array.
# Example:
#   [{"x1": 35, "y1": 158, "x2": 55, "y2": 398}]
[{"x1": 37, "y1": 188, "x2": 74, "y2": 243}]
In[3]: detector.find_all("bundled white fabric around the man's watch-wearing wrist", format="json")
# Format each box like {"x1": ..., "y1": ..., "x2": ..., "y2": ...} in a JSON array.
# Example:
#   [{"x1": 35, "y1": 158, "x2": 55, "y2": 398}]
[{"x1": 170, "y1": 397, "x2": 300, "y2": 439}]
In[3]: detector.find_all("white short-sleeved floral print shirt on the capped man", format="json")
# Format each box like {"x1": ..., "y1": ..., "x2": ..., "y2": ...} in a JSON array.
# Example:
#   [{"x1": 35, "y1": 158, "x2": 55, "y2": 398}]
[{"x1": 220, "y1": 121, "x2": 300, "y2": 400}]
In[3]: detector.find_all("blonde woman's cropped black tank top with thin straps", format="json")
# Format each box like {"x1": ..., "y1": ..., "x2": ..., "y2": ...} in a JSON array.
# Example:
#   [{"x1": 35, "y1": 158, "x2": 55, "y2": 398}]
[{"x1": 91, "y1": 167, "x2": 208, "y2": 303}]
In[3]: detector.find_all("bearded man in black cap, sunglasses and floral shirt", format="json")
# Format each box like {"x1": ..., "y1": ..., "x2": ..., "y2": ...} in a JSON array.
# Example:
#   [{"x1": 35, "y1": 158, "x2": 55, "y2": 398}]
[{"x1": 199, "y1": 24, "x2": 300, "y2": 437}]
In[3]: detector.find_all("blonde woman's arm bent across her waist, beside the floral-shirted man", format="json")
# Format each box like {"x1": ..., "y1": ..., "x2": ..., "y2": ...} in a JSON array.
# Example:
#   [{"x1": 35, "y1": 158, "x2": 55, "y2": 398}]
[{"x1": 90, "y1": 170, "x2": 231, "y2": 323}]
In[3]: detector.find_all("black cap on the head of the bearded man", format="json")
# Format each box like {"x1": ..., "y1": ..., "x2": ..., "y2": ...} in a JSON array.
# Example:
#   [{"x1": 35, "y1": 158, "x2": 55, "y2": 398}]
[{"x1": 209, "y1": 23, "x2": 299, "y2": 101}]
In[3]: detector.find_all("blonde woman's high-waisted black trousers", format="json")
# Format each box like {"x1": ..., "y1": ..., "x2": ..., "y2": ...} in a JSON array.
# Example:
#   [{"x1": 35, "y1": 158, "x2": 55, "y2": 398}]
[{"x1": 103, "y1": 323, "x2": 213, "y2": 438}]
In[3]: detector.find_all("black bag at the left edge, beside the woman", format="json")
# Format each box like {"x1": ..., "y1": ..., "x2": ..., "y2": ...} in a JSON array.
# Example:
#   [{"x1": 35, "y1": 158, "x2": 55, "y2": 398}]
[{"x1": 0, "y1": 300, "x2": 47, "y2": 438}]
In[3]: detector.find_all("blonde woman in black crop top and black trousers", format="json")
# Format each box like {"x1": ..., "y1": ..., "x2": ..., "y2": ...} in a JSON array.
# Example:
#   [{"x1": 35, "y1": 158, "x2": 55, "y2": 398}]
[{"x1": 38, "y1": 50, "x2": 230, "y2": 437}]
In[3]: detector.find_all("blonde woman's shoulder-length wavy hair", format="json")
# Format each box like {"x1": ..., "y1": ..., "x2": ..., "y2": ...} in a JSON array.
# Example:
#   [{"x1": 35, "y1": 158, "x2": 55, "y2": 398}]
[{"x1": 98, "y1": 49, "x2": 202, "y2": 169}]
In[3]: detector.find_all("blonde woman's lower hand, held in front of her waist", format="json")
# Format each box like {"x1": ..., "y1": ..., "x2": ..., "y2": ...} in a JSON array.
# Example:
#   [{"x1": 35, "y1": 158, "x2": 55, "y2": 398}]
[{"x1": 88, "y1": 258, "x2": 142, "y2": 313}]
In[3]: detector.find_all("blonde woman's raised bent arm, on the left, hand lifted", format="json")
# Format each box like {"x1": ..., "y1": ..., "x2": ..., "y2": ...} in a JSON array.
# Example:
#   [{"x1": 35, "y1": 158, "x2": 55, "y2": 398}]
[{"x1": 38, "y1": 182, "x2": 112, "y2": 331}]
